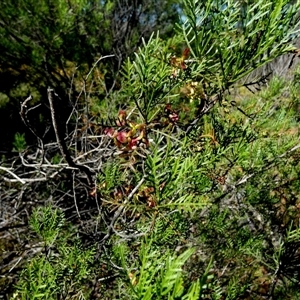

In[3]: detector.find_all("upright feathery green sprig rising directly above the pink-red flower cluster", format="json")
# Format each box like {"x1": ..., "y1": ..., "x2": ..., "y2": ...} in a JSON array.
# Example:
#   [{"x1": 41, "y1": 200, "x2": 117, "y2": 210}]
[{"x1": 122, "y1": 34, "x2": 176, "y2": 123}]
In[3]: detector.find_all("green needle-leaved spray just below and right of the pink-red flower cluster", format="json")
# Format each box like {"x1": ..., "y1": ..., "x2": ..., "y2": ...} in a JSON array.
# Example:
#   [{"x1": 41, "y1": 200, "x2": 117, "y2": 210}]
[{"x1": 145, "y1": 138, "x2": 211, "y2": 209}]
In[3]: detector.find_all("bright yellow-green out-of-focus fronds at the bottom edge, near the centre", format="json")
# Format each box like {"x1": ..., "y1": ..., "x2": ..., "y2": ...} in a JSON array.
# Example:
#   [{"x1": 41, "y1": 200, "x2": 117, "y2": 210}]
[{"x1": 113, "y1": 238, "x2": 207, "y2": 300}]
